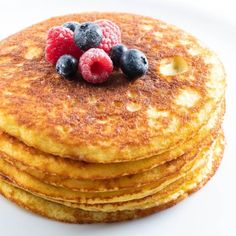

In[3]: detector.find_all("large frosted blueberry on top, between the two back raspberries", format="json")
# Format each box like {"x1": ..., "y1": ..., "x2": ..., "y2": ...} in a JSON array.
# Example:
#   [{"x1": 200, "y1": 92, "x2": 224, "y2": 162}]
[{"x1": 74, "y1": 22, "x2": 102, "y2": 51}]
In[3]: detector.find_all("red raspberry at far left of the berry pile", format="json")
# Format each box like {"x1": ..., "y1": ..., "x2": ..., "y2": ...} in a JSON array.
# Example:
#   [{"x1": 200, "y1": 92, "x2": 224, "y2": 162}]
[{"x1": 45, "y1": 26, "x2": 83, "y2": 64}]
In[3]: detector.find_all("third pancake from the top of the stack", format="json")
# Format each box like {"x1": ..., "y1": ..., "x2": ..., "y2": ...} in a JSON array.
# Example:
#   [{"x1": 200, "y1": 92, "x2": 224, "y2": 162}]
[{"x1": 5, "y1": 116, "x2": 221, "y2": 192}]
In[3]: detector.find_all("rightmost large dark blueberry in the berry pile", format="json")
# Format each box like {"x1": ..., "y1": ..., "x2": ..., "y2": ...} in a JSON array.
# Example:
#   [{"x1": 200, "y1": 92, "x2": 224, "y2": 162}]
[{"x1": 120, "y1": 49, "x2": 148, "y2": 79}]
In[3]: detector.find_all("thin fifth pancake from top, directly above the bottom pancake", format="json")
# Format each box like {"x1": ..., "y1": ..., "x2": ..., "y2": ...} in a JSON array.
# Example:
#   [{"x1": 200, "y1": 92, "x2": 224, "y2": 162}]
[{"x1": 49, "y1": 135, "x2": 224, "y2": 212}]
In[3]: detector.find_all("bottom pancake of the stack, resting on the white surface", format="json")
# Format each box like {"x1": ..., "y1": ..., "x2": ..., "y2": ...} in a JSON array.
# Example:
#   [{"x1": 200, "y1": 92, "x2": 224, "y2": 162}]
[{"x1": 0, "y1": 134, "x2": 223, "y2": 223}]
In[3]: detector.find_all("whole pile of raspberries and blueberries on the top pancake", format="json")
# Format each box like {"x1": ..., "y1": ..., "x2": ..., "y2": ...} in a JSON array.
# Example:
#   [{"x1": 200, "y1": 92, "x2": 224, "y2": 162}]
[{"x1": 45, "y1": 20, "x2": 148, "y2": 84}]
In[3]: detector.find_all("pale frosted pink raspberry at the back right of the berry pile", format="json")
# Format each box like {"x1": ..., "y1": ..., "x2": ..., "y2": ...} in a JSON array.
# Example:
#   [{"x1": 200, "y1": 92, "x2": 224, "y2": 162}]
[{"x1": 96, "y1": 20, "x2": 121, "y2": 53}]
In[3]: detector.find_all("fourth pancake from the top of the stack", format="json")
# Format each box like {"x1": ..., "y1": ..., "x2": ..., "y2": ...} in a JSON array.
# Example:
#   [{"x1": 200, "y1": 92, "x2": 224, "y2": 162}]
[{"x1": 0, "y1": 131, "x2": 222, "y2": 204}]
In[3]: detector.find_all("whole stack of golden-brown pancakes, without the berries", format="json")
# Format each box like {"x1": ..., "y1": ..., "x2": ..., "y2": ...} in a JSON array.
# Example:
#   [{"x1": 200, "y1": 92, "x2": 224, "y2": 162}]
[{"x1": 0, "y1": 13, "x2": 225, "y2": 223}]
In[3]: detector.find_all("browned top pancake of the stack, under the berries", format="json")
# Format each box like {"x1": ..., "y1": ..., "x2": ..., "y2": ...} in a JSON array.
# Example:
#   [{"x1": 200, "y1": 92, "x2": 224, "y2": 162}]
[{"x1": 0, "y1": 13, "x2": 225, "y2": 163}]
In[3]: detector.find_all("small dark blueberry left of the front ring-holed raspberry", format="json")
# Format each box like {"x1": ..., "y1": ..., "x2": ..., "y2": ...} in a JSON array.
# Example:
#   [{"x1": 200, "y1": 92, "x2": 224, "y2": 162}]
[{"x1": 56, "y1": 55, "x2": 78, "y2": 78}]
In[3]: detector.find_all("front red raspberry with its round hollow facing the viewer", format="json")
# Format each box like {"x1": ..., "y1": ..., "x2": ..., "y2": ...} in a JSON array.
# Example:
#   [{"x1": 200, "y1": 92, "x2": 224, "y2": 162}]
[{"x1": 79, "y1": 48, "x2": 113, "y2": 84}]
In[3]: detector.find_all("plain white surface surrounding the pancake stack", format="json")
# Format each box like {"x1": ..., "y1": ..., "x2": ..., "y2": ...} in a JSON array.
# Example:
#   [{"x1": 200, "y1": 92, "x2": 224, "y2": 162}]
[{"x1": 0, "y1": 0, "x2": 236, "y2": 236}]
